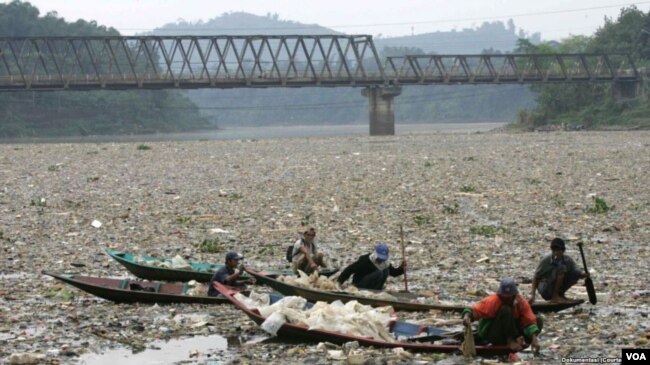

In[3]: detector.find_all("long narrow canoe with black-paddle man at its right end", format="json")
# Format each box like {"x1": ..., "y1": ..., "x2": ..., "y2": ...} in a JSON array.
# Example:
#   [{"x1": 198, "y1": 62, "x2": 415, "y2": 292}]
[{"x1": 246, "y1": 268, "x2": 584, "y2": 313}]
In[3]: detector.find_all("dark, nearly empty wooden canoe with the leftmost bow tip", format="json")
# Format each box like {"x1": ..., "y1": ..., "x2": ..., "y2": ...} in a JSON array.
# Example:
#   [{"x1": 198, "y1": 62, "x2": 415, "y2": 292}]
[{"x1": 43, "y1": 271, "x2": 230, "y2": 304}]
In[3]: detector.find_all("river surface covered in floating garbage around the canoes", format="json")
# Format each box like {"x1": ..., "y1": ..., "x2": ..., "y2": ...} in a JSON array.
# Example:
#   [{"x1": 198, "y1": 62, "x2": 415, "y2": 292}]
[{"x1": 0, "y1": 131, "x2": 650, "y2": 364}]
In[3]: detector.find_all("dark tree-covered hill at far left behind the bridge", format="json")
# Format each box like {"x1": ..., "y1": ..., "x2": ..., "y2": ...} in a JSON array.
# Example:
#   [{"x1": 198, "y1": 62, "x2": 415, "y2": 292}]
[{"x1": 0, "y1": 1, "x2": 210, "y2": 138}]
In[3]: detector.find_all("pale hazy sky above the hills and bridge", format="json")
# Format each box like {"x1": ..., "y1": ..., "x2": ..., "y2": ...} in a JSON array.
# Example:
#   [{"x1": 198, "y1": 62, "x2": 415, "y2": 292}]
[{"x1": 8, "y1": 0, "x2": 650, "y2": 40}]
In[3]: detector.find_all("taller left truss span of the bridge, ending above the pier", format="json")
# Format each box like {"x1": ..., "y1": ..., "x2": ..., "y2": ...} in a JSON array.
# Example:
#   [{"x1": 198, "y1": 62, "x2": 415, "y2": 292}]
[{"x1": 0, "y1": 35, "x2": 385, "y2": 90}]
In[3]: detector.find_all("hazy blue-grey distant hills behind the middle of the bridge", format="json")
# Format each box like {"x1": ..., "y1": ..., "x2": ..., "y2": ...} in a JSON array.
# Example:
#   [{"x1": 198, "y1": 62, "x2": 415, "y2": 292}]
[{"x1": 153, "y1": 12, "x2": 539, "y2": 126}]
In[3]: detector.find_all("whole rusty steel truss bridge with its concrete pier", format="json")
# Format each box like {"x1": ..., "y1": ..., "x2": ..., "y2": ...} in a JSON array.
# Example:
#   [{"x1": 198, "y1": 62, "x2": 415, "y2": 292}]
[{"x1": 0, "y1": 35, "x2": 643, "y2": 134}]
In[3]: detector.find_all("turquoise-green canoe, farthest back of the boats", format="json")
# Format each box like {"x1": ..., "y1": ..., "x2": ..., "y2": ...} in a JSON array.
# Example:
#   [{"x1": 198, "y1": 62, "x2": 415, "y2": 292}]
[{"x1": 106, "y1": 248, "x2": 338, "y2": 283}]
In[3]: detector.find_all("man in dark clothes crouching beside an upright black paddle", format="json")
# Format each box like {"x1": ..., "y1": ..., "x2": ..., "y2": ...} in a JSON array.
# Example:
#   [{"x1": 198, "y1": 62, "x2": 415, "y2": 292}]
[{"x1": 528, "y1": 238, "x2": 589, "y2": 304}]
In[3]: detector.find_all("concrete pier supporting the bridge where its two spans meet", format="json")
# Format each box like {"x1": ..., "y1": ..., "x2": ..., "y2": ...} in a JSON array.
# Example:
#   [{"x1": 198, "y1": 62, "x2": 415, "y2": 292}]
[{"x1": 361, "y1": 86, "x2": 402, "y2": 136}]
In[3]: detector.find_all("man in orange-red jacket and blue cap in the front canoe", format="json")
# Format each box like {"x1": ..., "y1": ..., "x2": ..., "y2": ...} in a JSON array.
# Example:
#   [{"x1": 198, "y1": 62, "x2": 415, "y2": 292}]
[{"x1": 462, "y1": 278, "x2": 542, "y2": 352}]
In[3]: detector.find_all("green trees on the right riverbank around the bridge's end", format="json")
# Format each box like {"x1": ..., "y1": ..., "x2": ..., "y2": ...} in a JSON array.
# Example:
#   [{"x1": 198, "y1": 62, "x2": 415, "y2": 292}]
[{"x1": 511, "y1": 7, "x2": 650, "y2": 130}]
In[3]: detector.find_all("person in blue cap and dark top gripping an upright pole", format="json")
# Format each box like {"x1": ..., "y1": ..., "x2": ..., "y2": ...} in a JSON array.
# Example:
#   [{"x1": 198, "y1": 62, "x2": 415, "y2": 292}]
[{"x1": 338, "y1": 243, "x2": 406, "y2": 290}]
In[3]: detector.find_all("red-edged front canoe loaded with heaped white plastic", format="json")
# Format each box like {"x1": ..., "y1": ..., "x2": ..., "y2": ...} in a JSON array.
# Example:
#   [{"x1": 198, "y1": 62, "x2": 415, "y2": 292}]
[{"x1": 214, "y1": 283, "x2": 511, "y2": 356}]
